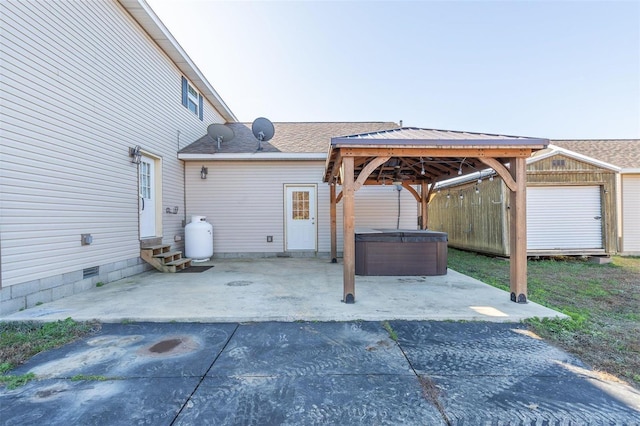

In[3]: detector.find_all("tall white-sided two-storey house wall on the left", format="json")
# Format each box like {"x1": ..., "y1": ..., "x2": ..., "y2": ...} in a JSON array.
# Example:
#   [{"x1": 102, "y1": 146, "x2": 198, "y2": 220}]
[{"x1": 0, "y1": 1, "x2": 222, "y2": 313}]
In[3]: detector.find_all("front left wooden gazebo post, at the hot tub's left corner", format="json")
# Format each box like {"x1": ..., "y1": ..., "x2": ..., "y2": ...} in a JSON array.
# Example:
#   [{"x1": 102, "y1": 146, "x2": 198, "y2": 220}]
[{"x1": 342, "y1": 157, "x2": 356, "y2": 303}]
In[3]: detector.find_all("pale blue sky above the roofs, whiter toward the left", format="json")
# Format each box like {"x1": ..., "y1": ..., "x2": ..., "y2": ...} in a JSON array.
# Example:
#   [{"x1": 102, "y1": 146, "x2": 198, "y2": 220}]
[{"x1": 146, "y1": 0, "x2": 640, "y2": 139}]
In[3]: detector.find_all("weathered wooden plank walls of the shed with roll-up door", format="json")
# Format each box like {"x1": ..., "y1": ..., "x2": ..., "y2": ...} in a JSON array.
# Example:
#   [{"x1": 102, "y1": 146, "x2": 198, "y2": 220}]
[{"x1": 429, "y1": 154, "x2": 618, "y2": 256}]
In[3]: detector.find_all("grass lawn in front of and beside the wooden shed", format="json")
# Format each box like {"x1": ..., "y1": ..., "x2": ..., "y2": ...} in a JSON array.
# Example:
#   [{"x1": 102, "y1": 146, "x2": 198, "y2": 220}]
[{"x1": 448, "y1": 249, "x2": 640, "y2": 388}]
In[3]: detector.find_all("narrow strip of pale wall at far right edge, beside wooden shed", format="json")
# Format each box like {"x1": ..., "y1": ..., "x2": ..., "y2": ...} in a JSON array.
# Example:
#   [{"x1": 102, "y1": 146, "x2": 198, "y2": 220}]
[{"x1": 622, "y1": 175, "x2": 640, "y2": 253}]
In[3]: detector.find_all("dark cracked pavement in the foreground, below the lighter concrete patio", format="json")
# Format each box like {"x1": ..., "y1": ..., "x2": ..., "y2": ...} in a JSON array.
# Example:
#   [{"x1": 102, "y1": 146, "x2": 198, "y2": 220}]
[{"x1": 0, "y1": 321, "x2": 640, "y2": 426}]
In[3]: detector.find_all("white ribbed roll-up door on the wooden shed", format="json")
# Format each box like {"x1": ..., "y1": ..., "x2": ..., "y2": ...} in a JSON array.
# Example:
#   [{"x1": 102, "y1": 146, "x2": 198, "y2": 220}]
[{"x1": 527, "y1": 186, "x2": 603, "y2": 250}]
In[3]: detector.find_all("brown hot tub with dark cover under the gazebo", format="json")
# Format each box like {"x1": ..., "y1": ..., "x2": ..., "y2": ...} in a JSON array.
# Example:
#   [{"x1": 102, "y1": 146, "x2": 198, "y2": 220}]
[{"x1": 356, "y1": 229, "x2": 447, "y2": 276}]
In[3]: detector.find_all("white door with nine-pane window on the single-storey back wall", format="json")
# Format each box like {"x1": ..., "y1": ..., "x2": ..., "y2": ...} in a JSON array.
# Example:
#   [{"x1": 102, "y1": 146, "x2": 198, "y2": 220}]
[{"x1": 285, "y1": 185, "x2": 317, "y2": 250}]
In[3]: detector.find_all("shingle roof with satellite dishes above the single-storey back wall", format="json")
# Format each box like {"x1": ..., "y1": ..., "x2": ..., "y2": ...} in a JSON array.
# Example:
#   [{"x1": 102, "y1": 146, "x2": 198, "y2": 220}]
[{"x1": 179, "y1": 122, "x2": 399, "y2": 154}]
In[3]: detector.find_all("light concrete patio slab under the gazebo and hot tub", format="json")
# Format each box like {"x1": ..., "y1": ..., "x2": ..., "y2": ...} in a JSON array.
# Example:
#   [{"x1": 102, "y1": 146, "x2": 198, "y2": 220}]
[{"x1": 0, "y1": 258, "x2": 564, "y2": 322}]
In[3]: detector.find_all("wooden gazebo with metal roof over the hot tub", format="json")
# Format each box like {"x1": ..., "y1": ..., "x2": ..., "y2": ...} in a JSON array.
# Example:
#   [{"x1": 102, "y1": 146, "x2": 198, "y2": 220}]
[{"x1": 324, "y1": 127, "x2": 549, "y2": 303}]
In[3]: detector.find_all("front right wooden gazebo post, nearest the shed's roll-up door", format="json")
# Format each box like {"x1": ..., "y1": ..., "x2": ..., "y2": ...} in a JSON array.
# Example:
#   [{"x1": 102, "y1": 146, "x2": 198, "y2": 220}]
[{"x1": 509, "y1": 157, "x2": 527, "y2": 303}]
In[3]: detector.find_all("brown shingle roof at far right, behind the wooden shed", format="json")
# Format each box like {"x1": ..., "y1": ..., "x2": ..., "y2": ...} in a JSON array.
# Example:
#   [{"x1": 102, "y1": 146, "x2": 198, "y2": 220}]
[{"x1": 549, "y1": 139, "x2": 640, "y2": 169}]
